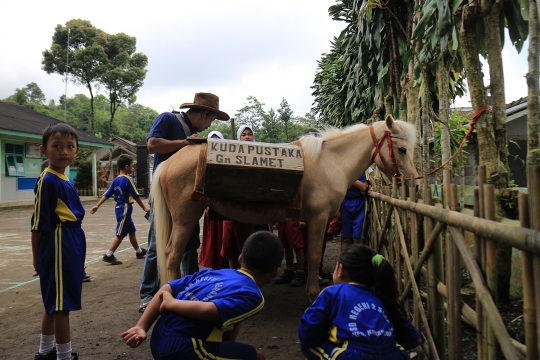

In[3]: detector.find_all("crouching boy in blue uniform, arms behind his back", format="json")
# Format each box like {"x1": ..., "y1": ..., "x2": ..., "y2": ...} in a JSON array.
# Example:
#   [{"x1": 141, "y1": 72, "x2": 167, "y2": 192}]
[{"x1": 121, "y1": 231, "x2": 283, "y2": 360}]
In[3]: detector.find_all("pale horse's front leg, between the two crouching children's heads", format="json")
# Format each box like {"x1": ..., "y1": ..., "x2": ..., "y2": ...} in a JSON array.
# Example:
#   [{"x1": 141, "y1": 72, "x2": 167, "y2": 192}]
[{"x1": 306, "y1": 216, "x2": 327, "y2": 302}]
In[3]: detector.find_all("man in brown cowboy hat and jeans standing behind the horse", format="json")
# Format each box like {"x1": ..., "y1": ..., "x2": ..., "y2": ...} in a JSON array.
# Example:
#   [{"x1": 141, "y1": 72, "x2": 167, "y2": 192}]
[{"x1": 139, "y1": 93, "x2": 229, "y2": 312}]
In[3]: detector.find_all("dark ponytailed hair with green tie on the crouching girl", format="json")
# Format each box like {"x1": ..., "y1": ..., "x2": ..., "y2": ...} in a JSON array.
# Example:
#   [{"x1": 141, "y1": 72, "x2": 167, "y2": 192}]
[{"x1": 339, "y1": 244, "x2": 405, "y2": 319}]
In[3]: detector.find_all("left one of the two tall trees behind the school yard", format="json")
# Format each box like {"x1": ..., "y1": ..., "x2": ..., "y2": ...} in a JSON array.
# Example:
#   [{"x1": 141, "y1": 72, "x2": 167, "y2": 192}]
[{"x1": 41, "y1": 19, "x2": 107, "y2": 134}]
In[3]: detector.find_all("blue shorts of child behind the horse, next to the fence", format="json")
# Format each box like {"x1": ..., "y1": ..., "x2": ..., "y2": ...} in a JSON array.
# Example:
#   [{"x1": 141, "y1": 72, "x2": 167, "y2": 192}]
[{"x1": 341, "y1": 198, "x2": 366, "y2": 239}]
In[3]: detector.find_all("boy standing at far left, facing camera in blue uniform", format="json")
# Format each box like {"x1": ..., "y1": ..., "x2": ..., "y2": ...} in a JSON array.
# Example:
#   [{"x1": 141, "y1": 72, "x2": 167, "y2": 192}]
[{"x1": 31, "y1": 123, "x2": 86, "y2": 360}]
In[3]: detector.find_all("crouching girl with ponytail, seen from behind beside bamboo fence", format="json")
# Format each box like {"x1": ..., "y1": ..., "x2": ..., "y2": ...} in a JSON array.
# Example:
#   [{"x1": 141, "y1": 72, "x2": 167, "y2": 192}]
[{"x1": 298, "y1": 244, "x2": 422, "y2": 360}]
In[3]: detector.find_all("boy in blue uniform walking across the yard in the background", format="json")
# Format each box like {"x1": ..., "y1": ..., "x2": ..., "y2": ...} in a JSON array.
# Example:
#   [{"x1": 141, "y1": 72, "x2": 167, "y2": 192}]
[{"x1": 90, "y1": 154, "x2": 150, "y2": 265}]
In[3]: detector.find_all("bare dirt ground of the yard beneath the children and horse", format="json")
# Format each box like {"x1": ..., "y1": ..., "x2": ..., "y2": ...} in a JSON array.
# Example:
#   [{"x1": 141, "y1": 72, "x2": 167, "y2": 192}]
[{"x1": 0, "y1": 201, "x2": 339, "y2": 360}]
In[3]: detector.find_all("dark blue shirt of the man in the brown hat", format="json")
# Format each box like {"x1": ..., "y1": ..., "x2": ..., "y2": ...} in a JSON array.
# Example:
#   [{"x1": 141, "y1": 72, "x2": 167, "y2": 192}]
[{"x1": 146, "y1": 112, "x2": 197, "y2": 171}]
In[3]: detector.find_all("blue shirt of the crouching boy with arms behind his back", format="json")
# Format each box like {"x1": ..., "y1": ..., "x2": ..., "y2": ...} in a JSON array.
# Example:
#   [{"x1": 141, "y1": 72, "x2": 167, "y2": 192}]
[{"x1": 154, "y1": 269, "x2": 264, "y2": 342}]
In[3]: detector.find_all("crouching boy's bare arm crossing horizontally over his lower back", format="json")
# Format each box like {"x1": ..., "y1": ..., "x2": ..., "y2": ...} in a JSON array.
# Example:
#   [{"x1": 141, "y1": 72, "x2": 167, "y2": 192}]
[{"x1": 160, "y1": 292, "x2": 221, "y2": 321}]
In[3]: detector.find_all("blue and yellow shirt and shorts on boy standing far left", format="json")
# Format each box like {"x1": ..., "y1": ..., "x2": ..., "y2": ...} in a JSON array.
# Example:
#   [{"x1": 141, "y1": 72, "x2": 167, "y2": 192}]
[{"x1": 31, "y1": 168, "x2": 86, "y2": 314}]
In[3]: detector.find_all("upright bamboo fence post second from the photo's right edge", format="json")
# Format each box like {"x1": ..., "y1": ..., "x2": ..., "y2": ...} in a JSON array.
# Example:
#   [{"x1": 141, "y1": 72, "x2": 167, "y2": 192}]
[{"x1": 484, "y1": 184, "x2": 498, "y2": 360}]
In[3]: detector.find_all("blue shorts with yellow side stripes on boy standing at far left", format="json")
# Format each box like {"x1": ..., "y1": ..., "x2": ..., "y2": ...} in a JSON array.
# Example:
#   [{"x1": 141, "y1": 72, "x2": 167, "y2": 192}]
[{"x1": 38, "y1": 223, "x2": 86, "y2": 315}]
